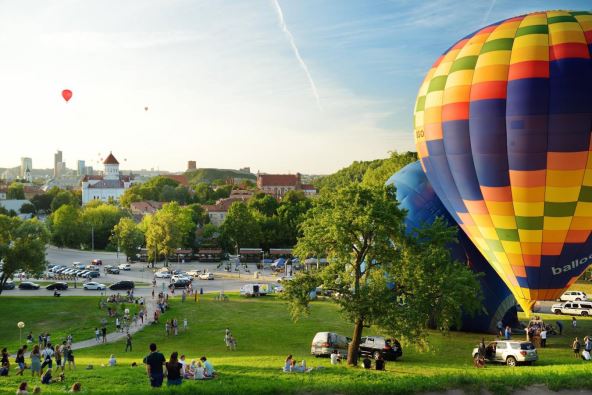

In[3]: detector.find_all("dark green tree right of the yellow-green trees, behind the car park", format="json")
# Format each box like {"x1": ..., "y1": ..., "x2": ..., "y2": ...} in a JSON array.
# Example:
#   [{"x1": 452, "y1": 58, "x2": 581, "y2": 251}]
[{"x1": 222, "y1": 202, "x2": 261, "y2": 251}]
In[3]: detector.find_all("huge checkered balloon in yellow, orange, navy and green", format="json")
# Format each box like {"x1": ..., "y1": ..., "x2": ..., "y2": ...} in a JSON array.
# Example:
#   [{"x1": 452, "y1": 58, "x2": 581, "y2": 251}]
[{"x1": 414, "y1": 11, "x2": 592, "y2": 312}]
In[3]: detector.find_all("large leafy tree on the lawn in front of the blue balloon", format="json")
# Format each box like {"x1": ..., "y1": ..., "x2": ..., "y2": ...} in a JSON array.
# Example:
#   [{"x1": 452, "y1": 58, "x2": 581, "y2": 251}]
[{"x1": 286, "y1": 184, "x2": 478, "y2": 365}]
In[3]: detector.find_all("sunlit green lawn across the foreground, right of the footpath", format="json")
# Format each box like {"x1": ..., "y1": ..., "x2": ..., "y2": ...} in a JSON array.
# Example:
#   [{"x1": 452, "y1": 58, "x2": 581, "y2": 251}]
[{"x1": 0, "y1": 295, "x2": 592, "y2": 394}]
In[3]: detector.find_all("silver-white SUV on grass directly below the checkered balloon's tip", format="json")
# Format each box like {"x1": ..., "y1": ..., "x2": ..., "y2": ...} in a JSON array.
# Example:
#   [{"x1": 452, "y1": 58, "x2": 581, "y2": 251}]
[{"x1": 472, "y1": 340, "x2": 539, "y2": 366}]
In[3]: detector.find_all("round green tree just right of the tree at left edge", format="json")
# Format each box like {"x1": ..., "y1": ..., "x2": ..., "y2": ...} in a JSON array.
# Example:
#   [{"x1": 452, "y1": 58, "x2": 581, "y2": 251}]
[{"x1": 48, "y1": 204, "x2": 87, "y2": 248}]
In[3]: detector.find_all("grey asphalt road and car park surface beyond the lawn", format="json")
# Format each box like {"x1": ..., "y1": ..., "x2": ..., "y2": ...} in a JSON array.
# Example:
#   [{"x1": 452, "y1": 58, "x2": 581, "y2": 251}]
[{"x1": 2, "y1": 247, "x2": 284, "y2": 296}]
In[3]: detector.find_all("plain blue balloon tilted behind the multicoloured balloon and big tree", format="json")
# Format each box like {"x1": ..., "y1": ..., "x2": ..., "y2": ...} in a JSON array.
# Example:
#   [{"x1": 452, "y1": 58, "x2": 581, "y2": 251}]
[{"x1": 386, "y1": 162, "x2": 518, "y2": 333}]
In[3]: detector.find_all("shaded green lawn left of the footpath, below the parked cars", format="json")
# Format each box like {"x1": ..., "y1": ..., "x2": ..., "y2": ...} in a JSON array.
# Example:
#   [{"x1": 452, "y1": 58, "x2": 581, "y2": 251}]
[{"x1": 0, "y1": 291, "x2": 144, "y2": 353}]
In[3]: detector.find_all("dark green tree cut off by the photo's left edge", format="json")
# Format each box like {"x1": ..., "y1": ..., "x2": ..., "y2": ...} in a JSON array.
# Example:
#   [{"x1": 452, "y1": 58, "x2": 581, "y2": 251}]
[{"x1": 0, "y1": 215, "x2": 49, "y2": 294}]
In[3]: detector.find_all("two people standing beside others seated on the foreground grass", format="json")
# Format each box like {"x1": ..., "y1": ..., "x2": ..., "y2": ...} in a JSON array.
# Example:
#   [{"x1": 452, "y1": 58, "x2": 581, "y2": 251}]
[{"x1": 144, "y1": 343, "x2": 216, "y2": 388}]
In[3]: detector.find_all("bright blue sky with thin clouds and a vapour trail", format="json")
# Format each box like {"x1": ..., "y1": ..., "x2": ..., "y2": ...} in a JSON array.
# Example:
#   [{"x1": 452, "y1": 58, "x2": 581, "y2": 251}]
[{"x1": 0, "y1": 0, "x2": 591, "y2": 174}]
